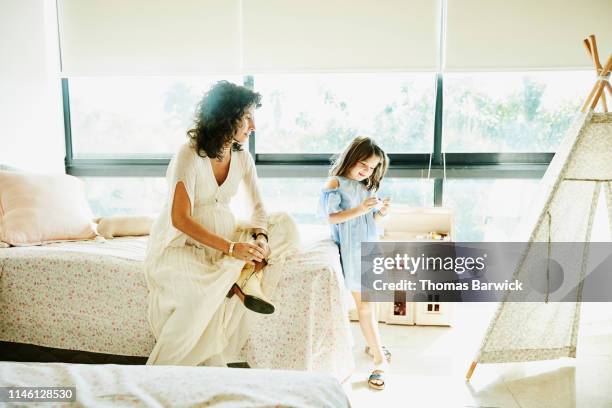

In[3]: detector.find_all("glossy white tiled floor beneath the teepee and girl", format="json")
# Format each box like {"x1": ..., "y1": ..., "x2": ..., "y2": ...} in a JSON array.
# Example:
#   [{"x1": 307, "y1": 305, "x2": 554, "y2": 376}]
[{"x1": 344, "y1": 303, "x2": 612, "y2": 408}]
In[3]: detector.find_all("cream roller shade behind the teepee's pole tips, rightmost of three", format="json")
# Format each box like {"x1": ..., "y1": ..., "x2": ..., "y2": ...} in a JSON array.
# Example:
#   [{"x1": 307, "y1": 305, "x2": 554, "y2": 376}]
[{"x1": 445, "y1": 0, "x2": 612, "y2": 71}]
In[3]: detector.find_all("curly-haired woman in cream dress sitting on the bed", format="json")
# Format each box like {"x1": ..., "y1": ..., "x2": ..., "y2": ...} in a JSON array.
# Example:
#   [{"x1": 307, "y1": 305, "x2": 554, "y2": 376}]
[{"x1": 145, "y1": 81, "x2": 297, "y2": 365}]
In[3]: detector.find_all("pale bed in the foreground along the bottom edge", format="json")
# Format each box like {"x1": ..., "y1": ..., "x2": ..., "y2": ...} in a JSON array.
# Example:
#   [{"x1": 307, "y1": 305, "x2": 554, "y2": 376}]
[{"x1": 0, "y1": 363, "x2": 349, "y2": 408}]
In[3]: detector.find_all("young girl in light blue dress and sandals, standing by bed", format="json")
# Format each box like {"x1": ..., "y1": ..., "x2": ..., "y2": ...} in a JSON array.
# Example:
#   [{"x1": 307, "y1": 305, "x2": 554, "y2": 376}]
[{"x1": 320, "y1": 136, "x2": 391, "y2": 389}]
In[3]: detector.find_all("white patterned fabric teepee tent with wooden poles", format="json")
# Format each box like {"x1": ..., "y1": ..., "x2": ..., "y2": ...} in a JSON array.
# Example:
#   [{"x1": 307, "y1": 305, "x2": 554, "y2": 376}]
[{"x1": 467, "y1": 37, "x2": 612, "y2": 380}]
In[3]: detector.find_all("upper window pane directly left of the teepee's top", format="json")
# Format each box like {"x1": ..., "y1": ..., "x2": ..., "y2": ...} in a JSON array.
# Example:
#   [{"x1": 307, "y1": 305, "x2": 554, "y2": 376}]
[{"x1": 443, "y1": 71, "x2": 593, "y2": 152}]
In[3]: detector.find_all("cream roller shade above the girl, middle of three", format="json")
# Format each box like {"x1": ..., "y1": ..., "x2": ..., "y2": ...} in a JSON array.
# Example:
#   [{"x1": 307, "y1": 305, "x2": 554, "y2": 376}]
[{"x1": 242, "y1": 0, "x2": 440, "y2": 72}]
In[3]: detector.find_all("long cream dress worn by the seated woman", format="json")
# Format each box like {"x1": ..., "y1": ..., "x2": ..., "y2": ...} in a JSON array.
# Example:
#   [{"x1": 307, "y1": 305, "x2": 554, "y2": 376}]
[{"x1": 145, "y1": 143, "x2": 298, "y2": 365}]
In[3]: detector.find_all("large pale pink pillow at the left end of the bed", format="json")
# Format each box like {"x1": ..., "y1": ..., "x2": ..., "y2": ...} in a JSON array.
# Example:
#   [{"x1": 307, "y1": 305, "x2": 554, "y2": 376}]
[{"x1": 0, "y1": 171, "x2": 95, "y2": 246}]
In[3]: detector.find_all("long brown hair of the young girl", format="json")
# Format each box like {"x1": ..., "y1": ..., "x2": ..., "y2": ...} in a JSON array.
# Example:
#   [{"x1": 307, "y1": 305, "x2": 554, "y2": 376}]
[{"x1": 329, "y1": 136, "x2": 389, "y2": 191}]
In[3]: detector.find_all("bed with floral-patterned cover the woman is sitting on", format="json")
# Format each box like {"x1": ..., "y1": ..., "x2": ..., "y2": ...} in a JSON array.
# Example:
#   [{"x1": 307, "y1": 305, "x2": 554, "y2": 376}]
[{"x1": 0, "y1": 229, "x2": 354, "y2": 380}]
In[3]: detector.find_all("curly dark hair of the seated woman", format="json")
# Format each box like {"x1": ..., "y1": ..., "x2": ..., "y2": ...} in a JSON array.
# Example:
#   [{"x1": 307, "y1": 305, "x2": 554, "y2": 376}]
[{"x1": 187, "y1": 81, "x2": 261, "y2": 160}]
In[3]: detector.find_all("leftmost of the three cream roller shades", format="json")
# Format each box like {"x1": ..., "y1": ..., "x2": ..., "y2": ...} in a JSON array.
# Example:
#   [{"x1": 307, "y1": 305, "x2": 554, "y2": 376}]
[{"x1": 58, "y1": 0, "x2": 240, "y2": 75}]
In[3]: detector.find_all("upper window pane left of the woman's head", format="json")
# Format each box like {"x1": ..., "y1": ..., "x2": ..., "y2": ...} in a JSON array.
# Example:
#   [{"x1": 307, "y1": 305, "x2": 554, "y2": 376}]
[{"x1": 70, "y1": 77, "x2": 242, "y2": 158}]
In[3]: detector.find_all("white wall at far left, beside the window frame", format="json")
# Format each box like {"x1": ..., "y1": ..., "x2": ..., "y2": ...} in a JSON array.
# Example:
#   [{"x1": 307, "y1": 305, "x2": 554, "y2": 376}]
[{"x1": 0, "y1": 0, "x2": 65, "y2": 172}]
